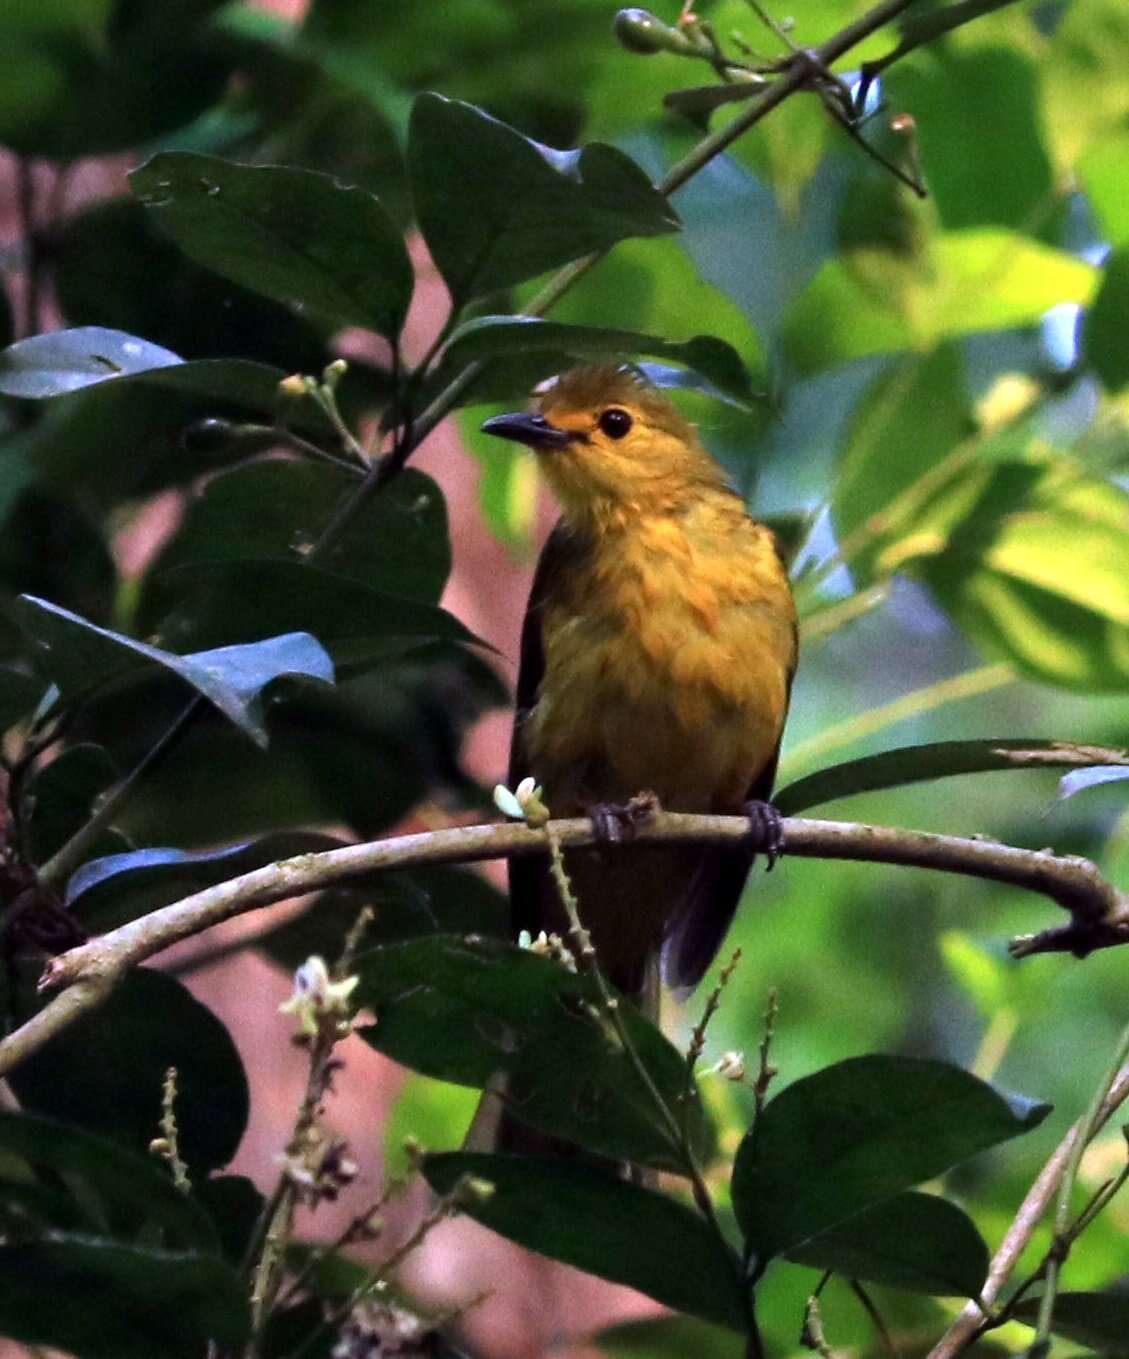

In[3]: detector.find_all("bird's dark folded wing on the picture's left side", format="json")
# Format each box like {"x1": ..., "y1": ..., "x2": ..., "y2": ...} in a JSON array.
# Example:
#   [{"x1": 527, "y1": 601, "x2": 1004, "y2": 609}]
[{"x1": 508, "y1": 520, "x2": 579, "y2": 938}]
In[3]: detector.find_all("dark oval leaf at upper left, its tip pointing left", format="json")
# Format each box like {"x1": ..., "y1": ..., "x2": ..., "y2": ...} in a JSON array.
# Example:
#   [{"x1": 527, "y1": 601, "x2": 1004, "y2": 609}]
[{"x1": 129, "y1": 151, "x2": 413, "y2": 340}]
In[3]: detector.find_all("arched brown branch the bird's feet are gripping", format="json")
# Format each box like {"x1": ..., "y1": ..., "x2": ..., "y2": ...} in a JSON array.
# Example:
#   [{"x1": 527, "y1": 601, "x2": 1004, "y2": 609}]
[{"x1": 0, "y1": 811, "x2": 1129, "y2": 1075}]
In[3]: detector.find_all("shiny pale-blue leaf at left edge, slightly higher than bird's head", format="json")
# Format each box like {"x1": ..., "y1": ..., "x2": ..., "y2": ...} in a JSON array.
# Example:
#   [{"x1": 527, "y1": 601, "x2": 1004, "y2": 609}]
[{"x1": 0, "y1": 326, "x2": 183, "y2": 400}]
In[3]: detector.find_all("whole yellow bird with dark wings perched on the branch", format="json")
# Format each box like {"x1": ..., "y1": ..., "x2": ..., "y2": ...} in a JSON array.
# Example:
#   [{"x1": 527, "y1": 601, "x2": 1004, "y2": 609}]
[{"x1": 482, "y1": 366, "x2": 796, "y2": 1017}]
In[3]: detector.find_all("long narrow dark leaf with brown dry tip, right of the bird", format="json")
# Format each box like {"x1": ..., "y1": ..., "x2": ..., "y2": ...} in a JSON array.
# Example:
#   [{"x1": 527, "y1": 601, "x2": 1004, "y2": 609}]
[{"x1": 773, "y1": 738, "x2": 1129, "y2": 817}]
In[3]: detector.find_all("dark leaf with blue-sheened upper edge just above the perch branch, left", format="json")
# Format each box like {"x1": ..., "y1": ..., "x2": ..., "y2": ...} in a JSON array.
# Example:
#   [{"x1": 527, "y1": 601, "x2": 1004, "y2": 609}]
[{"x1": 67, "y1": 830, "x2": 344, "y2": 934}]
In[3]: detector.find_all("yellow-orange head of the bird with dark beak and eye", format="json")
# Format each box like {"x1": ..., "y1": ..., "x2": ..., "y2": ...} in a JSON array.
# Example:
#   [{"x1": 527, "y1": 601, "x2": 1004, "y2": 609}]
[{"x1": 482, "y1": 366, "x2": 725, "y2": 523}]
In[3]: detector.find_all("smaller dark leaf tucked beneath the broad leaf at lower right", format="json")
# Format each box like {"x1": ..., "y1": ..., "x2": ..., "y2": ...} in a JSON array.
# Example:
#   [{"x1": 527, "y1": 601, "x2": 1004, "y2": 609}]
[{"x1": 787, "y1": 1192, "x2": 988, "y2": 1298}]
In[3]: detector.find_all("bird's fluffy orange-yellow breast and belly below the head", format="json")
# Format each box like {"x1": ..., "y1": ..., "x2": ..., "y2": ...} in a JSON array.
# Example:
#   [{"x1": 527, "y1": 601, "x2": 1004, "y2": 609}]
[{"x1": 526, "y1": 493, "x2": 795, "y2": 811}]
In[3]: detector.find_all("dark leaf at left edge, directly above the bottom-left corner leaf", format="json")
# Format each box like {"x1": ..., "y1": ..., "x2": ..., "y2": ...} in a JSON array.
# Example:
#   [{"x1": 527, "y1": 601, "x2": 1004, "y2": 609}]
[{"x1": 0, "y1": 1112, "x2": 216, "y2": 1253}]
